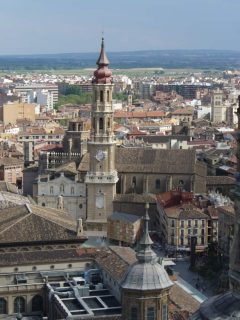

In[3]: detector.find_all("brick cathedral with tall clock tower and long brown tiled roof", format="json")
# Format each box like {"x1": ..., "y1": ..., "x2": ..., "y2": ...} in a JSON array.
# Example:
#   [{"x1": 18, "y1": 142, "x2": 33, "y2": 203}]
[{"x1": 29, "y1": 39, "x2": 206, "y2": 233}]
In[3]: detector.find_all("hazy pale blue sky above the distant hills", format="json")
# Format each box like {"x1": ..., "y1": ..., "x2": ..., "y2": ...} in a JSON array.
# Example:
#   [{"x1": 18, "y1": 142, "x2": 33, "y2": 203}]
[{"x1": 0, "y1": 0, "x2": 240, "y2": 55}]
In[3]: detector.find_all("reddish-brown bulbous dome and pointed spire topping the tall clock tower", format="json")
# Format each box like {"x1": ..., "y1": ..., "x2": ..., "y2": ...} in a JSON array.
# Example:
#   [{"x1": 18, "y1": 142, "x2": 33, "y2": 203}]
[{"x1": 92, "y1": 38, "x2": 112, "y2": 84}]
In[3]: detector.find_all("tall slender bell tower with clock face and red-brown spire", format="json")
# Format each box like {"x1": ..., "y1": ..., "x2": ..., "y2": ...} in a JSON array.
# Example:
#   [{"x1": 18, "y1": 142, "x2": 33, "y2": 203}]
[{"x1": 85, "y1": 38, "x2": 118, "y2": 231}]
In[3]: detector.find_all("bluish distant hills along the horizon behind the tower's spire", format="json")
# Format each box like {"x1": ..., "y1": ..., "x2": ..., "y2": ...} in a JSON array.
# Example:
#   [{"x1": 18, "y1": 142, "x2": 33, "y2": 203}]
[{"x1": 0, "y1": 50, "x2": 240, "y2": 71}]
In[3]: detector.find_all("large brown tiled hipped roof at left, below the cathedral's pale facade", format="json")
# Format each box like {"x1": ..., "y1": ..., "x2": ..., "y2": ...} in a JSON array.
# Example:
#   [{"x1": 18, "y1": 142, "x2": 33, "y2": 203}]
[{"x1": 0, "y1": 204, "x2": 84, "y2": 243}]
